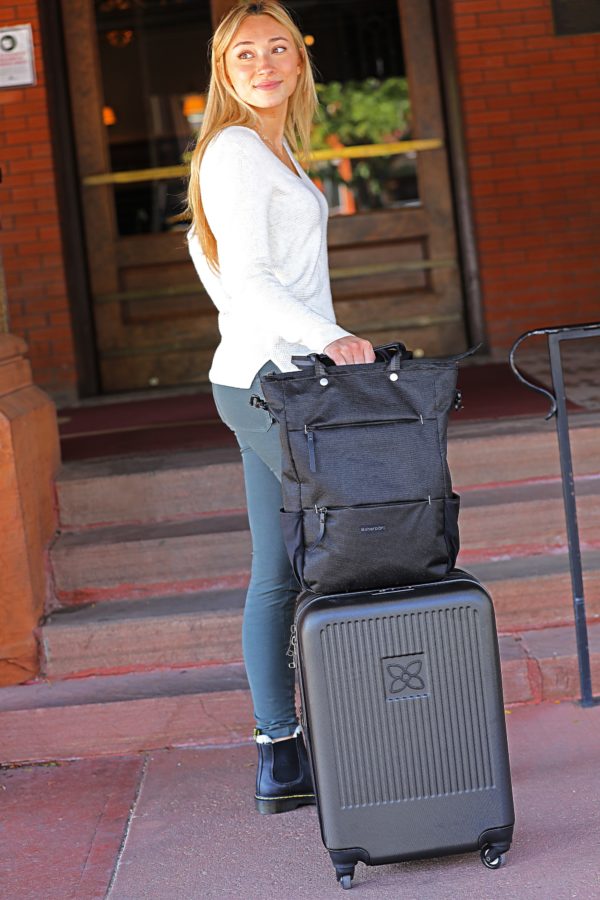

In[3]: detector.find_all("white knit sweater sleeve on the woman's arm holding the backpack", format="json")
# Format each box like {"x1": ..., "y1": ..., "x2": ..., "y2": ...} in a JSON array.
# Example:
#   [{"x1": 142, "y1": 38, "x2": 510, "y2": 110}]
[{"x1": 200, "y1": 133, "x2": 349, "y2": 353}]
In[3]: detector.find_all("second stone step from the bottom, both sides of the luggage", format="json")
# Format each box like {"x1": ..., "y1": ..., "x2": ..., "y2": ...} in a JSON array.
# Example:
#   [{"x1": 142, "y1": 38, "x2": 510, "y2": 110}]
[{"x1": 40, "y1": 551, "x2": 600, "y2": 678}]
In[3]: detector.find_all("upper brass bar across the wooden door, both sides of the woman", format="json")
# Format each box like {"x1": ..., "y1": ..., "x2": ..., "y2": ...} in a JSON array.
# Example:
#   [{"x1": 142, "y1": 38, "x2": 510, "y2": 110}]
[{"x1": 81, "y1": 138, "x2": 444, "y2": 187}]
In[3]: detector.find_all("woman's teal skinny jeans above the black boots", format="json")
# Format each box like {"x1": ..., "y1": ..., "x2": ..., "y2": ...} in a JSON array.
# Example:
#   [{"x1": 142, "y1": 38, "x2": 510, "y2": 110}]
[{"x1": 212, "y1": 362, "x2": 300, "y2": 738}]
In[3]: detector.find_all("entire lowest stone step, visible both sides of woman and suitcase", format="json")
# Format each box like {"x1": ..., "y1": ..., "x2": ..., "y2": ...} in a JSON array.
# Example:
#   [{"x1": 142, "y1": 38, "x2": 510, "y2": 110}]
[{"x1": 0, "y1": 624, "x2": 600, "y2": 764}]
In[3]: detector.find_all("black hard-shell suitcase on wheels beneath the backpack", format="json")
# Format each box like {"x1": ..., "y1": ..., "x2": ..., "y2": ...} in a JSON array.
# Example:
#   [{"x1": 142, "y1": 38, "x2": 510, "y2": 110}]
[{"x1": 292, "y1": 570, "x2": 514, "y2": 888}]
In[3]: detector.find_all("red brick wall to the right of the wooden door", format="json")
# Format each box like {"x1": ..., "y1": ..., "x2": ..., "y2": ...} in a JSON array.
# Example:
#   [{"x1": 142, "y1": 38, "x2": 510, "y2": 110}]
[{"x1": 452, "y1": 0, "x2": 600, "y2": 349}]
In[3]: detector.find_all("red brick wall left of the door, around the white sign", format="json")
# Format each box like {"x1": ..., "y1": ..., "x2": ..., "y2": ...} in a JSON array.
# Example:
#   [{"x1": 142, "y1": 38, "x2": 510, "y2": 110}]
[{"x1": 0, "y1": 0, "x2": 76, "y2": 395}]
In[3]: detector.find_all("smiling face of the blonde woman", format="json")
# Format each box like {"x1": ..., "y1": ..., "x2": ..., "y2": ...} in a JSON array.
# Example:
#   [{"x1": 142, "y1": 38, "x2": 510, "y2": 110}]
[{"x1": 225, "y1": 16, "x2": 302, "y2": 116}]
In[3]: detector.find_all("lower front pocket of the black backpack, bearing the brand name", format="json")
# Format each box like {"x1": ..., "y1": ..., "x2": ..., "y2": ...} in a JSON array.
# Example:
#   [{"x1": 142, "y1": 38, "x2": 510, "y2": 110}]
[{"x1": 301, "y1": 494, "x2": 459, "y2": 593}]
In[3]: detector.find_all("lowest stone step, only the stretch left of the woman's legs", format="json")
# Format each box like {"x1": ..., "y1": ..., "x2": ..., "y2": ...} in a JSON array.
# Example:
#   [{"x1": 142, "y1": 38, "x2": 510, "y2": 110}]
[{"x1": 0, "y1": 665, "x2": 253, "y2": 763}]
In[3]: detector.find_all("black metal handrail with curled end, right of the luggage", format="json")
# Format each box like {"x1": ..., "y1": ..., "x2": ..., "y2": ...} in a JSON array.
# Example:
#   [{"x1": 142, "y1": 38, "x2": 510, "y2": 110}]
[{"x1": 509, "y1": 322, "x2": 600, "y2": 706}]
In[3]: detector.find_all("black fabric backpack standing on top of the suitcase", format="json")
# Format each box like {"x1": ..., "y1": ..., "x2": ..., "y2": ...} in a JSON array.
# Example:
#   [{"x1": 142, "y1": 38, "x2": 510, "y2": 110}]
[{"x1": 258, "y1": 344, "x2": 474, "y2": 593}]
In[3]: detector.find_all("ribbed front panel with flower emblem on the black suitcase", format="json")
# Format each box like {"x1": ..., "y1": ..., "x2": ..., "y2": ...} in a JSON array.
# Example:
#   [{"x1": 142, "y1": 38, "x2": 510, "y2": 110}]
[{"x1": 321, "y1": 604, "x2": 494, "y2": 809}]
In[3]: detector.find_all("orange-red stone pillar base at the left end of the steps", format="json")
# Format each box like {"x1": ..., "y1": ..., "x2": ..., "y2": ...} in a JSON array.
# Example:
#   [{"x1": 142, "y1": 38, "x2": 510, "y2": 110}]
[{"x1": 0, "y1": 334, "x2": 60, "y2": 687}]
